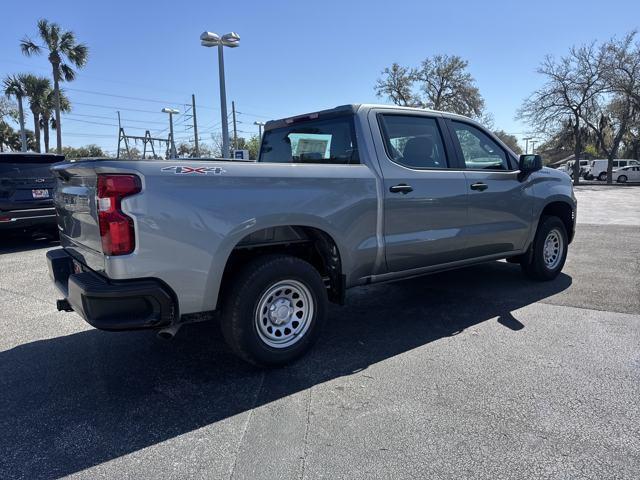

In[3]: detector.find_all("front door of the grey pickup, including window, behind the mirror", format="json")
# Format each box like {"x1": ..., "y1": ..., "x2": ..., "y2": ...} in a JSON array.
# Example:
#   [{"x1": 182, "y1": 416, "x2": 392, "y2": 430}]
[{"x1": 446, "y1": 119, "x2": 534, "y2": 258}]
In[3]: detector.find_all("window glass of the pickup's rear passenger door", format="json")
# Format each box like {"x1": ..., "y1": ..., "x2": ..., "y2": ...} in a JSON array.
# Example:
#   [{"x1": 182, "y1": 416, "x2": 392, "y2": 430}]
[{"x1": 380, "y1": 114, "x2": 447, "y2": 169}]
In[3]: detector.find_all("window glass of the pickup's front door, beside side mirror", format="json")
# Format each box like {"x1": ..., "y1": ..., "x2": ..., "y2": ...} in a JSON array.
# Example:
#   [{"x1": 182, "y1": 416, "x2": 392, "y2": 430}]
[{"x1": 451, "y1": 122, "x2": 509, "y2": 170}]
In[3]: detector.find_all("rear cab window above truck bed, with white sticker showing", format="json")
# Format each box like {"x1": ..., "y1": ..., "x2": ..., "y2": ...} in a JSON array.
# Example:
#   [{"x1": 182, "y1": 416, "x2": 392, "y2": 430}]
[{"x1": 259, "y1": 117, "x2": 360, "y2": 164}]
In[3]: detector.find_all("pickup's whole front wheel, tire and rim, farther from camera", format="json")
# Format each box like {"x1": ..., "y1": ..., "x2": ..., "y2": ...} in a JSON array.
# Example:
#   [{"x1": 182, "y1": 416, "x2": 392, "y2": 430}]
[{"x1": 520, "y1": 217, "x2": 569, "y2": 281}]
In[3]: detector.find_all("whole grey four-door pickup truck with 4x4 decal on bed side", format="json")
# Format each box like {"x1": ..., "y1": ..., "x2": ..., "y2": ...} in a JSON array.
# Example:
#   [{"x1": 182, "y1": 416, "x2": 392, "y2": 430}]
[{"x1": 47, "y1": 105, "x2": 576, "y2": 366}]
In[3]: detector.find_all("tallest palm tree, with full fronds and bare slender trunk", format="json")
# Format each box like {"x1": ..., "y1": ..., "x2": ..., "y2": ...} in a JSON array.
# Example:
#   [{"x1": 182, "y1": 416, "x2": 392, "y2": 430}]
[{"x1": 20, "y1": 19, "x2": 89, "y2": 153}]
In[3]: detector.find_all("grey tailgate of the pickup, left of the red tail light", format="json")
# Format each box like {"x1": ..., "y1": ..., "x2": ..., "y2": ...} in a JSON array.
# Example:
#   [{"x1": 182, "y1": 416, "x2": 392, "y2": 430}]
[{"x1": 52, "y1": 162, "x2": 104, "y2": 271}]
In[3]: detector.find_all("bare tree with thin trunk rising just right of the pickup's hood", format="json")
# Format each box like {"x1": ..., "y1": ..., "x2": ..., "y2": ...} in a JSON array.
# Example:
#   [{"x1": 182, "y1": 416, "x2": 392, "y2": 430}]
[{"x1": 517, "y1": 43, "x2": 604, "y2": 185}]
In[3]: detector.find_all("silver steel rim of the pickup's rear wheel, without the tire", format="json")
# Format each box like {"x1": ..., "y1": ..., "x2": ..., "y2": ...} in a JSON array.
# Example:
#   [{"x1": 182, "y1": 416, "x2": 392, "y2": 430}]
[{"x1": 254, "y1": 280, "x2": 315, "y2": 348}]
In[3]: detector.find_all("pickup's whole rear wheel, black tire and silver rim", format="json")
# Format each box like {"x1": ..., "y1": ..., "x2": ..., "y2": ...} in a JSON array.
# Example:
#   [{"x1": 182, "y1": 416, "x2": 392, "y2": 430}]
[{"x1": 222, "y1": 255, "x2": 328, "y2": 367}]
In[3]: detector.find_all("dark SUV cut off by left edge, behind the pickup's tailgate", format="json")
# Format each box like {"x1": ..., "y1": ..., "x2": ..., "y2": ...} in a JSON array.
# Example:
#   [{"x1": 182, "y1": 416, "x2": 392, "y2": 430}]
[{"x1": 0, "y1": 152, "x2": 64, "y2": 235}]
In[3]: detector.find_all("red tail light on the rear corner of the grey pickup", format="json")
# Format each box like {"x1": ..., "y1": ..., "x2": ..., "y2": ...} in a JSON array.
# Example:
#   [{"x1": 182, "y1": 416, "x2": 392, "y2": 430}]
[{"x1": 98, "y1": 174, "x2": 142, "y2": 255}]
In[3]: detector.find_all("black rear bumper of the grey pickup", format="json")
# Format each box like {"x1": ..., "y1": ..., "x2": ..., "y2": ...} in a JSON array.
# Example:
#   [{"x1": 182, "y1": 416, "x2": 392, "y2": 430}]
[{"x1": 47, "y1": 248, "x2": 178, "y2": 330}]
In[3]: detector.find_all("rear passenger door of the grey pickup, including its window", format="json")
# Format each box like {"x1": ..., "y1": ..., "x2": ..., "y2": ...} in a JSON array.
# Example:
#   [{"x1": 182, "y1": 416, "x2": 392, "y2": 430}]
[{"x1": 369, "y1": 109, "x2": 467, "y2": 272}]
